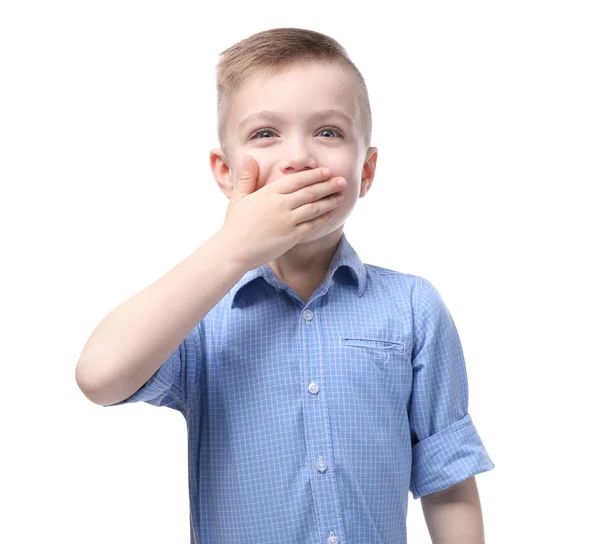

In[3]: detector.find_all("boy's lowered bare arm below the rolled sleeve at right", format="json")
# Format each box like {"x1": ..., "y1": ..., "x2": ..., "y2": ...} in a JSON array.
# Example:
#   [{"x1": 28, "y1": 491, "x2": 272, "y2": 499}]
[{"x1": 421, "y1": 476, "x2": 485, "y2": 544}]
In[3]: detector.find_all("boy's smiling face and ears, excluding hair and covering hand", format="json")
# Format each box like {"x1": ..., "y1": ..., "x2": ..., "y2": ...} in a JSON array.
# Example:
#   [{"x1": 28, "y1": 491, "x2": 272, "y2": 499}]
[{"x1": 210, "y1": 62, "x2": 377, "y2": 231}]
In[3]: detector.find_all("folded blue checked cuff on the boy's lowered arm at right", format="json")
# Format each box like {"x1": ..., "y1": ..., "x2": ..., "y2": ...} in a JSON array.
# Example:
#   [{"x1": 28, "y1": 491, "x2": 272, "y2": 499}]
[{"x1": 410, "y1": 414, "x2": 496, "y2": 499}]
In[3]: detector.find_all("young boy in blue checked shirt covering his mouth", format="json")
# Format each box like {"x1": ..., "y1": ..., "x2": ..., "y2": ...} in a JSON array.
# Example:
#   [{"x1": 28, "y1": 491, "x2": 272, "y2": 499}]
[{"x1": 76, "y1": 28, "x2": 495, "y2": 544}]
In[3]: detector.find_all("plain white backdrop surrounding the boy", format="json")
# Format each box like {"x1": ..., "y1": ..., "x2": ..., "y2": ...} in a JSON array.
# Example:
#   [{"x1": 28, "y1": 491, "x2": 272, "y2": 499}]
[{"x1": 0, "y1": 0, "x2": 600, "y2": 544}]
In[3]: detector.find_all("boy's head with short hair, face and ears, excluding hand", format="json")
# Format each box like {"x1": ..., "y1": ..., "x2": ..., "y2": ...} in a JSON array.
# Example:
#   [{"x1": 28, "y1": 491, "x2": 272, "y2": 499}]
[{"x1": 210, "y1": 28, "x2": 377, "y2": 227}]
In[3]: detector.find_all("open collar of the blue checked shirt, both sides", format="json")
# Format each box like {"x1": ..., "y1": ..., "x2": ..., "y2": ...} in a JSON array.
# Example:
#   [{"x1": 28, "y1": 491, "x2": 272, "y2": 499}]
[{"x1": 230, "y1": 232, "x2": 367, "y2": 307}]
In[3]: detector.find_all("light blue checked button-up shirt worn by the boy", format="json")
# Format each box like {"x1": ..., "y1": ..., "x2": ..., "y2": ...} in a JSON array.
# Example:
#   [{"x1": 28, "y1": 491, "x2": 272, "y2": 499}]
[{"x1": 105, "y1": 233, "x2": 495, "y2": 544}]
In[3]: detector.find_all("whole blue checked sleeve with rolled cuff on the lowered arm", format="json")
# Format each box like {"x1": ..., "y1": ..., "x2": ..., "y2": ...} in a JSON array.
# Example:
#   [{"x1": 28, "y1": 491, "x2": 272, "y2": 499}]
[{"x1": 409, "y1": 278, "x2": 495, "y2": 499}]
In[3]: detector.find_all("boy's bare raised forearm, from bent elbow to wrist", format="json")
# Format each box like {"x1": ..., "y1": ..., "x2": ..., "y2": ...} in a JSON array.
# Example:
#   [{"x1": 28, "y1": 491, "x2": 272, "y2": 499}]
[{"x1": 75, "y1": 229, "x2": 247, "y2": 405}]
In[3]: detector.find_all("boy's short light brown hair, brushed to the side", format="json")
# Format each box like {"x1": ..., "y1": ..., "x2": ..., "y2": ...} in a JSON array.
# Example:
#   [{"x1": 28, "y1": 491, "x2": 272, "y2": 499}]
[{"x1": 216, "y1": 28, "x2": 372, "y2": 154}]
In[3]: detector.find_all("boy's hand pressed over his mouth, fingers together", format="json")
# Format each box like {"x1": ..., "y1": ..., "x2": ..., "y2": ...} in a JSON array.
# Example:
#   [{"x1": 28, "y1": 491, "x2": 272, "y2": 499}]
[{"x1": 221, "y1": 155, "x2": 343, "y2": 270}]
